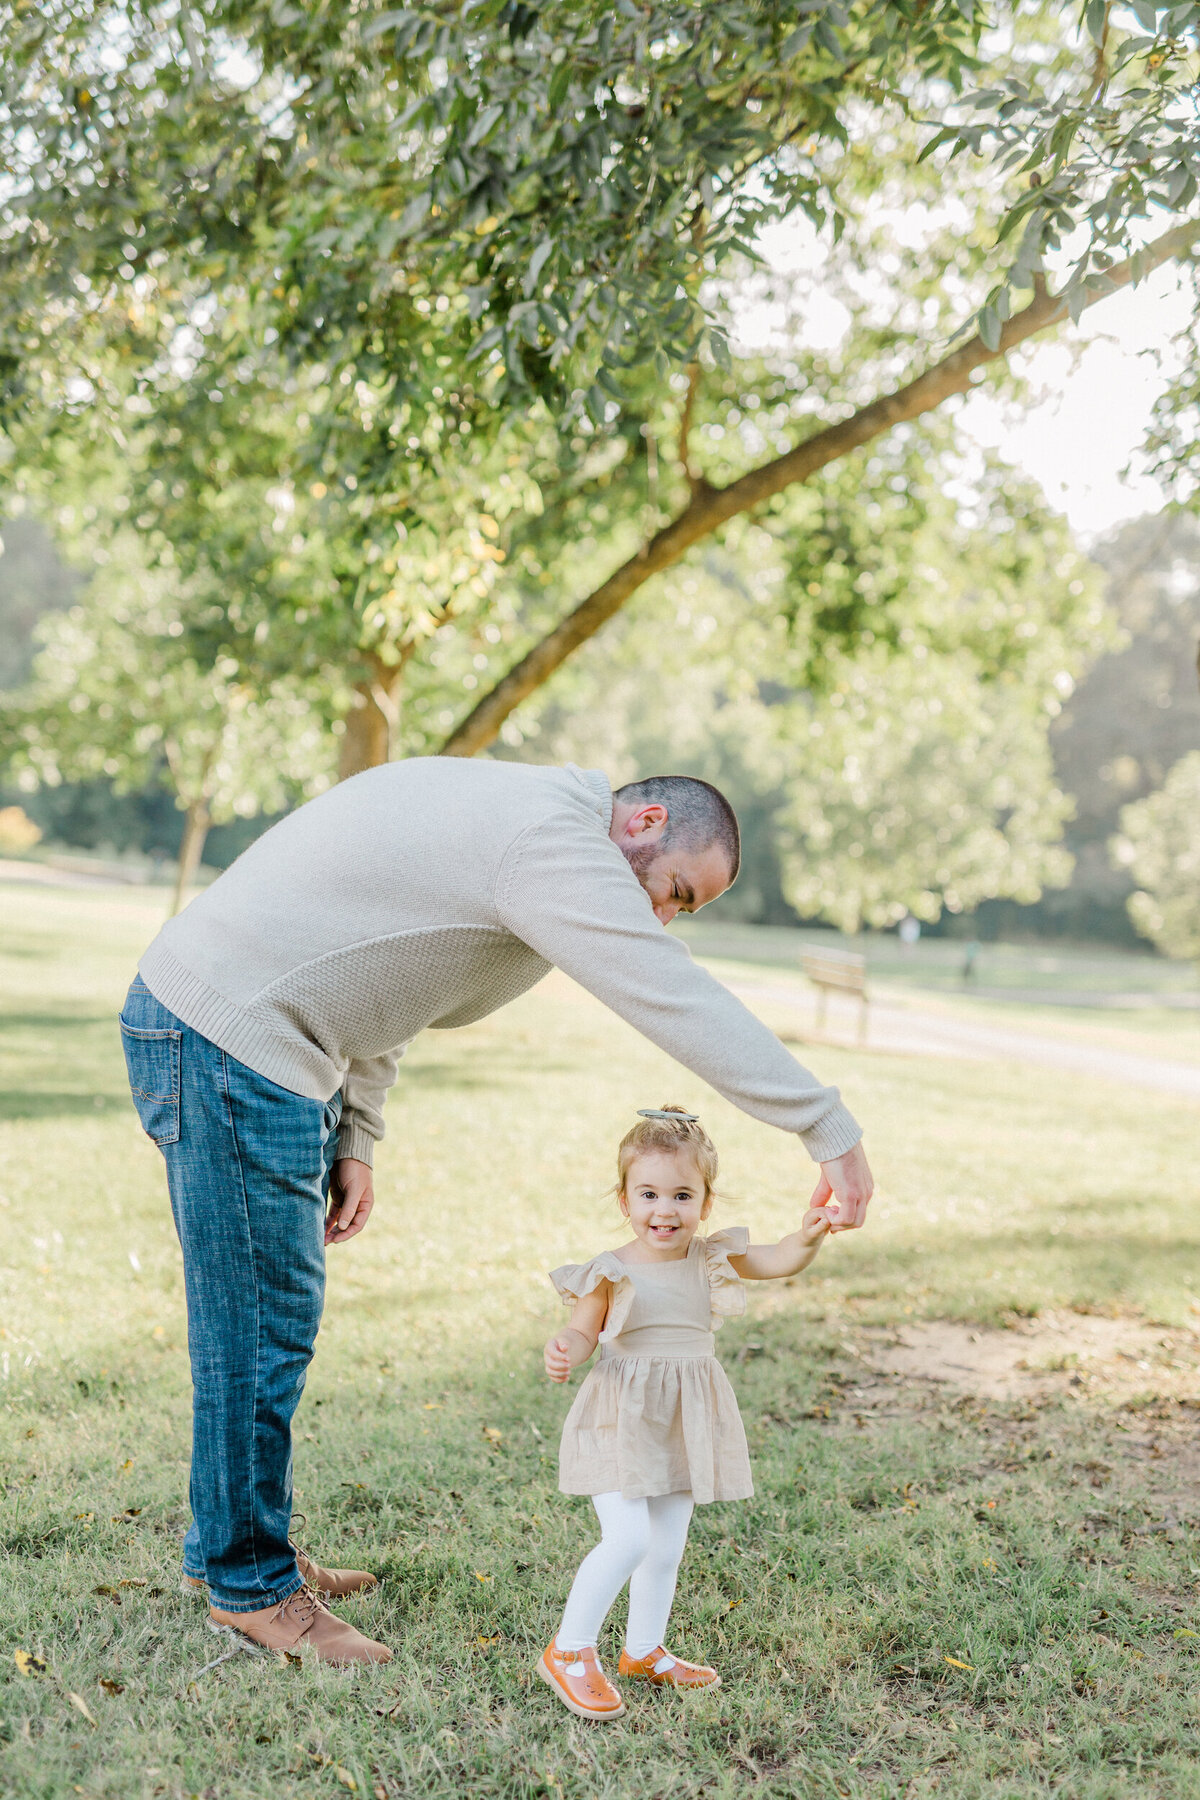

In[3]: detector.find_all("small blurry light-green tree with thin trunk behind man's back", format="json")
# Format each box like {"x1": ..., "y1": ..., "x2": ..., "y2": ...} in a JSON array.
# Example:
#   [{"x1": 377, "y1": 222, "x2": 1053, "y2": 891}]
[{"x1": 4, "y1": 533, "x2": 333, "y2": 911}]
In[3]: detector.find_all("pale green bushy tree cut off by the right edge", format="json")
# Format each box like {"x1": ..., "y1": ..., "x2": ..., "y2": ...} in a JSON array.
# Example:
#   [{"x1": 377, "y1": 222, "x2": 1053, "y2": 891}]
[{"x1": 1112, "y1": 751, "x2": 1200, "y2": 961}]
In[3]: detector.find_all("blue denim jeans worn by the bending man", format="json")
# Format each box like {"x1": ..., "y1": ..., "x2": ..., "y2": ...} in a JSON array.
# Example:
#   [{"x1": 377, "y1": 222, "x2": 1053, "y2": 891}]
[{"x1": 121, "y1": 977, "x2": 342, "y2": 1613}]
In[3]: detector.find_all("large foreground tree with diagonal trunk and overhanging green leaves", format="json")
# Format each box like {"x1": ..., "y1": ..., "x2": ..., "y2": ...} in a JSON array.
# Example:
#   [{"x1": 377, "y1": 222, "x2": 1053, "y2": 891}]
[{"x1": 0, "y1": 0, "x2": 1200, "y2": 754}]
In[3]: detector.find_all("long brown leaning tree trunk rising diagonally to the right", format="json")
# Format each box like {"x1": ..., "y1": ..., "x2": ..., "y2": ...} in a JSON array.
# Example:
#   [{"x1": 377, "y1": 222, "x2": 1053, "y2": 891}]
[{"x1": 439, "y1": 223, "x2": 1200, "y2": 756}]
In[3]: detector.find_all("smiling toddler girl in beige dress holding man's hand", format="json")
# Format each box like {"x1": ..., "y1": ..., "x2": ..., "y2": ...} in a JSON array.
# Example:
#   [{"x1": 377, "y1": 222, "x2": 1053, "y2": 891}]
[{"x1": 538, "y1": 1107, "x2": 837, "y2": 1719}]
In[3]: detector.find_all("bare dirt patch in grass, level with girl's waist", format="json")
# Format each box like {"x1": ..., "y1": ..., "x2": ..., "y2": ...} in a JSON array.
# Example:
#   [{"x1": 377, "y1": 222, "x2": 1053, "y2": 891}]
[{"x1": 864, "y1": 1312, "x2": 1200, "y2": 1406}]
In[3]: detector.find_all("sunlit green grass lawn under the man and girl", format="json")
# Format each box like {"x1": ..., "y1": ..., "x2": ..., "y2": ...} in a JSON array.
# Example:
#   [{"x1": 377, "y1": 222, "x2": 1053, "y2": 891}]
[{"x1": 0, "y1": 889, "x2": 1200, "y2": 1800}]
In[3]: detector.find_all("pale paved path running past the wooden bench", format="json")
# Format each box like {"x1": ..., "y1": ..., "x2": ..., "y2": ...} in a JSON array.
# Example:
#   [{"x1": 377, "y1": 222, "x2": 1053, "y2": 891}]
[{"x1": 727, "y1": 979, "x2": 1200, "y2": 1100}]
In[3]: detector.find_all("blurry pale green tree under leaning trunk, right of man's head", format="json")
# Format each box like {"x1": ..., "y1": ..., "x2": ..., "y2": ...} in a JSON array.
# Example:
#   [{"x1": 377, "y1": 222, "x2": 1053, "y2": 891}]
[{"x1": 496, "y1": 432, "x2": 1110, "y2": 931}]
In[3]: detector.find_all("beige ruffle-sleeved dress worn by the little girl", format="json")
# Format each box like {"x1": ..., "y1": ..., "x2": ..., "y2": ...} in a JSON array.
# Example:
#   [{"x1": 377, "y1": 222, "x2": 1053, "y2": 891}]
[{"x1": 551, "y1": 1226, "x2": 754, "y2": 1505}]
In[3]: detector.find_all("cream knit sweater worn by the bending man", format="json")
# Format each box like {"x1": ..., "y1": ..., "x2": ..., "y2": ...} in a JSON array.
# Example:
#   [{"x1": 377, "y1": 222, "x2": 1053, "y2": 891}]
[{"x1": 140, "y1": 756, "x2": 860, "y2": 1163}]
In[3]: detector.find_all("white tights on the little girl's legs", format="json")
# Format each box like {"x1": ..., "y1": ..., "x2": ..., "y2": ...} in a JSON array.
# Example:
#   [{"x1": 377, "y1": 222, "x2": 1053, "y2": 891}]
[{"x1": 556, "y1": 1494, "x2": 693, "y2": 1656}]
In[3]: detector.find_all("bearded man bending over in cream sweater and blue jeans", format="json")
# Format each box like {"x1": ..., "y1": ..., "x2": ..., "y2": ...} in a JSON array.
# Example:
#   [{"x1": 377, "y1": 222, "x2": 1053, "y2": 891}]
[{"x1": 121, "y1": 758, "x2": 871, "y2": 1663}]
